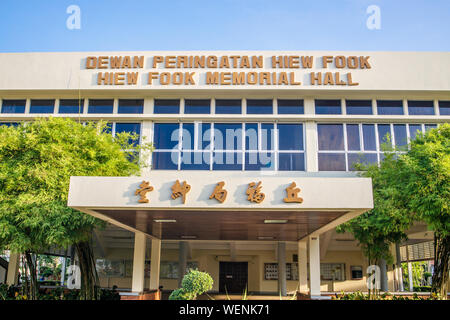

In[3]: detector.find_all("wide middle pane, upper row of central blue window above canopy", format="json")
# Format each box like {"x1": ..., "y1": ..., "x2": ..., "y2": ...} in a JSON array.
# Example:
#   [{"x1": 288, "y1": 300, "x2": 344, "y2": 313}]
[{"x1": 214, "y1": 123, "x2": 242, "y2": 150}]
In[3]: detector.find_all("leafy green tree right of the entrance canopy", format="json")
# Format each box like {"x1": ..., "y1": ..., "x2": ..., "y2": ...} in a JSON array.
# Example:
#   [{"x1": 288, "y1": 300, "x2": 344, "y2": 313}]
[{"x1": 339, "y1": 124, "x2": 450, "y2": 299}]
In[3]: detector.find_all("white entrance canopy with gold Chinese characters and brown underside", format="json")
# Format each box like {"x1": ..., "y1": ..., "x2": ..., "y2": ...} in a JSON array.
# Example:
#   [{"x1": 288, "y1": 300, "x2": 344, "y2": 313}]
[{"x1": 68, "y1": 171, "x2": 373, "y2": 241}]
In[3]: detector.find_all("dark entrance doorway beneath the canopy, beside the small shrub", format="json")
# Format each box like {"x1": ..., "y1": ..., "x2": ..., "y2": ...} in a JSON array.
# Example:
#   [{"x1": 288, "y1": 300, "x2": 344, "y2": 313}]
[{"x1": 219, "y1": 262, "x2": 248, "y2": 294}]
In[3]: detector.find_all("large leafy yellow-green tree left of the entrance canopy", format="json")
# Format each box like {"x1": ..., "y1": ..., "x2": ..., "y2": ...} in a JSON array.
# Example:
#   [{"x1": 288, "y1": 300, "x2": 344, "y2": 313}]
[{"x1": 0, "y1": 118, "x2": 151, "y2": 299}]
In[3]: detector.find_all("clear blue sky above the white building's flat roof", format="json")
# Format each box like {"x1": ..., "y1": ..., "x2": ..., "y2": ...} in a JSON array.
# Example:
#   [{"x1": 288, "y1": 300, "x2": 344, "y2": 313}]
[{"x1": 0, "y1": 0, "x2": 450, "y2": 52}]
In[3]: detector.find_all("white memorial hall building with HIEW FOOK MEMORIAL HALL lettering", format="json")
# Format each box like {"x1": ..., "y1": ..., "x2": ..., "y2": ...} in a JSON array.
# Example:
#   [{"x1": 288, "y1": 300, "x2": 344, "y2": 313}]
[{"x1": 0, "y1": 51, "x2": 450, "y2": 296}]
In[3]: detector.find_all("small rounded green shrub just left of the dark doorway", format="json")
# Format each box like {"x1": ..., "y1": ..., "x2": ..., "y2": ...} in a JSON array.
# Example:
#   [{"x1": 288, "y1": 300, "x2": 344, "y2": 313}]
[{"x1": 169, "y1": 270, "x2": 213, "y2": 300}]
